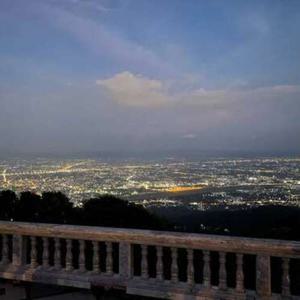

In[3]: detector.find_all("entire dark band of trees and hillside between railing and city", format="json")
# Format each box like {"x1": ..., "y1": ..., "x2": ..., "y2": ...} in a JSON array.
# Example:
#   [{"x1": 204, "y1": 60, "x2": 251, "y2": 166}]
[{"x1": 0, "y1": 190, "x2": 300, "y2": 240}]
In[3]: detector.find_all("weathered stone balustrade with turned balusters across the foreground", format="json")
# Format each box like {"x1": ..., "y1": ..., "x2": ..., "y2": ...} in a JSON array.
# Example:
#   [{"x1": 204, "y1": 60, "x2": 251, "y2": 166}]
[{"x1": 0, "y1": 221, "x2": 300, "y2": 299}]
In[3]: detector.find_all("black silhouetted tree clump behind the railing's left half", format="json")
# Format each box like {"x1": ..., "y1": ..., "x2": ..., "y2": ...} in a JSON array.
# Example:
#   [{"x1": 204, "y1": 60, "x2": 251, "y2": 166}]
[{"x1": 0, "y1": 191, "x2": 168, "y2": 229}]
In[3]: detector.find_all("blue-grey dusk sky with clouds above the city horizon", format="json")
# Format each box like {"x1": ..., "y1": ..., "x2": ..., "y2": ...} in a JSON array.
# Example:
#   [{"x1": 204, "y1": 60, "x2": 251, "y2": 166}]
[{"x1": 0, "y1": 0, "x2": 300, "y2": 154}]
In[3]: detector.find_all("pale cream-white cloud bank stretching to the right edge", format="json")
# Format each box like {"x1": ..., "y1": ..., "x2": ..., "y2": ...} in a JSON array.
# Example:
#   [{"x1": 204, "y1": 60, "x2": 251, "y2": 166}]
[{"x1": 96, "y1": 71, "x2": 300, "y2": 109}]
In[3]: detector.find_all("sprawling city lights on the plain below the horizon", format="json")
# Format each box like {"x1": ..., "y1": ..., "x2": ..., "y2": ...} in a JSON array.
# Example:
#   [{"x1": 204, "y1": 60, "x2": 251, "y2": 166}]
[{"x1": 0, "y1": 158, "x2": 300, "y2": 210}]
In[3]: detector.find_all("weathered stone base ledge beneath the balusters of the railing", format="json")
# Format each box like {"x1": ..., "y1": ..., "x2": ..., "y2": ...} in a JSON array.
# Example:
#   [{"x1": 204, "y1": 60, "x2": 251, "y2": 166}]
[{"x1": 0, "y1": 264, "x2": 299, "y2": 300}]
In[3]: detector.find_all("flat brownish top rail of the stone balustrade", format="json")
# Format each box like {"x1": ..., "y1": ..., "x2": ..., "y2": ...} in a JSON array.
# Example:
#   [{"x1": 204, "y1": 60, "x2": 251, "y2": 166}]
[{"x1": 0, "y1": 221, "x2": 300, "y2": 257}]
